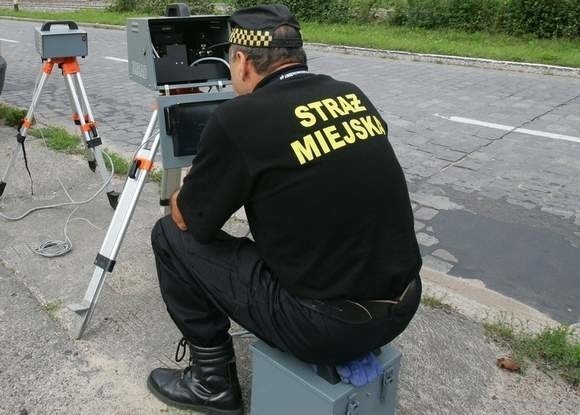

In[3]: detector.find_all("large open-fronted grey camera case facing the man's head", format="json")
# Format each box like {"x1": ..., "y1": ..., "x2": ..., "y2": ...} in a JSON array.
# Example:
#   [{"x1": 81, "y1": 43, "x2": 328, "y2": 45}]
[{"x1": 127, "y1": 16, "x2": 230, "y2": 91}]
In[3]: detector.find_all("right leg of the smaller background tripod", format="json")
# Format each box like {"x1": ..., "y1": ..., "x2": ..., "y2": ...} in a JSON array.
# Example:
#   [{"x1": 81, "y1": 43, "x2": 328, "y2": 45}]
[{"x1": 64, "y1": 72, "x2": 119, "y2": 209}]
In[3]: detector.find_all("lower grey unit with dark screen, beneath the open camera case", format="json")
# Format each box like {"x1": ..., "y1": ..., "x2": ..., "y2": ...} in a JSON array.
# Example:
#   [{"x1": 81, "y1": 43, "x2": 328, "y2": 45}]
[{"x1": 157, "y1": 91, "x2": 234, "y2": 169}]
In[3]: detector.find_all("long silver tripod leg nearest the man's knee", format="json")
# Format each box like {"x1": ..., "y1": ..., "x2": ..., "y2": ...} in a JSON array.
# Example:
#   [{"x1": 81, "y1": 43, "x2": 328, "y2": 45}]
[{"x1": 69, "y1": 111, "x2": 159, "y2": 339}]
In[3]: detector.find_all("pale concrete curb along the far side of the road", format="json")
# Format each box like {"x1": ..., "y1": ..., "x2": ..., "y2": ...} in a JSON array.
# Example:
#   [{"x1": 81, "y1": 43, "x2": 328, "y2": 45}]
[{"x1": 0, "y1": 16, "x2": 580, "y2": 78}]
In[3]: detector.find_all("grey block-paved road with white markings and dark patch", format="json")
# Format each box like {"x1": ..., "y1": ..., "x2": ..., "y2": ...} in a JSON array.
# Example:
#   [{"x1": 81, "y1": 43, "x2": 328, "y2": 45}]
[{"x1": 0, "y1": 20, "x2": 580, "y2": 323}]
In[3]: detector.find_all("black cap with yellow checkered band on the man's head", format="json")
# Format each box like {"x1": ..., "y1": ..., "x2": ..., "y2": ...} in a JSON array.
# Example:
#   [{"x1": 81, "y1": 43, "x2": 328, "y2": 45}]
[{"x1": 230, "y1": 4, "x2": 302, "y2": 48}]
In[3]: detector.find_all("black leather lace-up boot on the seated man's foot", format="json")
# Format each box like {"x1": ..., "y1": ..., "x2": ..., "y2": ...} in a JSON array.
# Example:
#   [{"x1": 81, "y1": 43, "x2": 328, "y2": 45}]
[{"x1": 147, "y1": 337, "x2": 244, "y2": 415}]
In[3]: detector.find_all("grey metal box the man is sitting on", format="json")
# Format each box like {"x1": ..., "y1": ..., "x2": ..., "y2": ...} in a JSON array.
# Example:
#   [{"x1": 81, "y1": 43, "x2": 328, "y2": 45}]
[{"x1": 250, "y1": 341, "x2": 401, "y2": 415}]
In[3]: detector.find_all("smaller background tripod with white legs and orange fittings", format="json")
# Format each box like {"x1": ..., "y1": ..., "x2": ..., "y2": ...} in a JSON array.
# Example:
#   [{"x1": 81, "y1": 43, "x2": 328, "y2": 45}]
[{"x1": 0, "y1": 57, "x2": 119, "y2": 209}]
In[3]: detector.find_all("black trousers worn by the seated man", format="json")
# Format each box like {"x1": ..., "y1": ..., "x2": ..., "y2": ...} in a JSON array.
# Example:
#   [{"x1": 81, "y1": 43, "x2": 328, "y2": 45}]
[{"x1": 151, "y1": 216, "x2": 421, "y2": 364}]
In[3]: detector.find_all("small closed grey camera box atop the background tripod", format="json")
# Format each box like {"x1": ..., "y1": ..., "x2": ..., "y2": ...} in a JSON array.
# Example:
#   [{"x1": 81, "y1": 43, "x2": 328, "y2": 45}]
[{"x1": 34, "y1": 21, "x2": 89, "y2": 60}]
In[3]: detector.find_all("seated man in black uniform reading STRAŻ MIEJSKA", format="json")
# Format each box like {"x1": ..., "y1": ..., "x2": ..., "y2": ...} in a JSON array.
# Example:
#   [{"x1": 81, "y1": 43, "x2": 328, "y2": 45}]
[{"x1": 148, "y1": 5, "x2": 421, "y2": 414}]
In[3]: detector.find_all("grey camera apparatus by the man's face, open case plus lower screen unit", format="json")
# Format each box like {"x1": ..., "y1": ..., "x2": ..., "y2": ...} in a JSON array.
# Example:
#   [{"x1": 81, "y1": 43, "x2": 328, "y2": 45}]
[{"x1": 127, "y1": 12, "x2": 234, "y2": 170}]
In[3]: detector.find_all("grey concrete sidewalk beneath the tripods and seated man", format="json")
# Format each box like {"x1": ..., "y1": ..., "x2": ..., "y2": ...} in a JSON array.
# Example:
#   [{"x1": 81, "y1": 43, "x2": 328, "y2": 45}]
[{"x1": 0, "y1": 127, "x2": 580, "y2": 415}]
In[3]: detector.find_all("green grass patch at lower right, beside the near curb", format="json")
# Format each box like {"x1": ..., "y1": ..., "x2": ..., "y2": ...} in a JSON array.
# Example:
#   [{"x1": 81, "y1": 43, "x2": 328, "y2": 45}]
[{"x1": 484, "y1": 322, "x2": 580, "y2": 388}]
